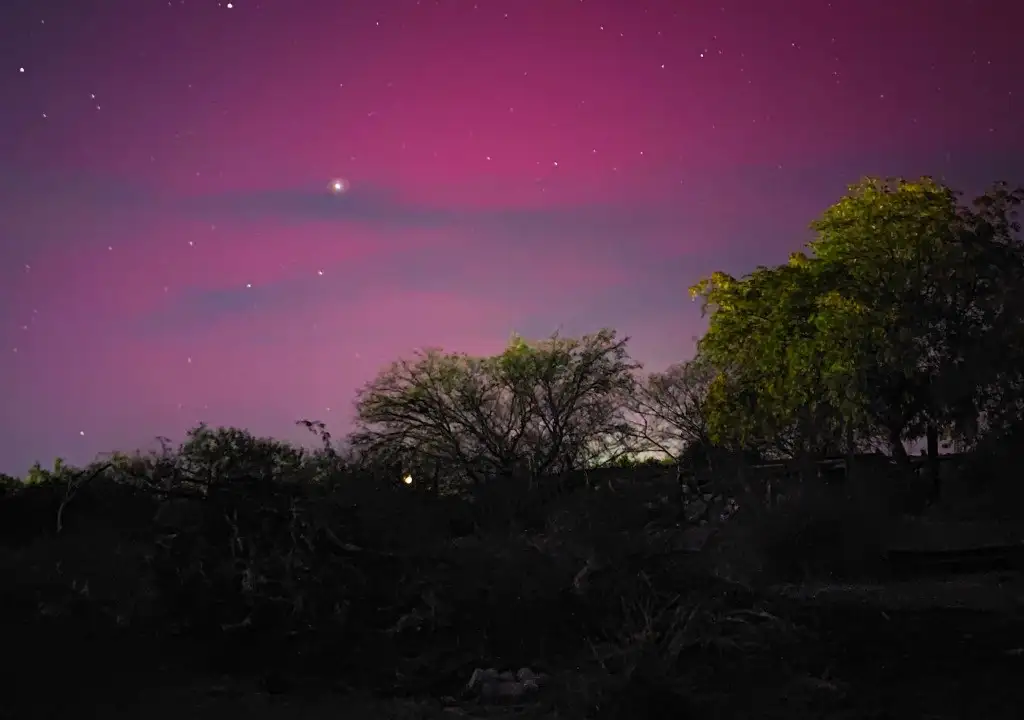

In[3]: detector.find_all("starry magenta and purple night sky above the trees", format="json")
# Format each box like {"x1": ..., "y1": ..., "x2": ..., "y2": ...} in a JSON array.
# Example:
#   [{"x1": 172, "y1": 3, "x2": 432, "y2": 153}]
[{"x1": 0, "y1": 0, "x2": 1024, "y2": 474}]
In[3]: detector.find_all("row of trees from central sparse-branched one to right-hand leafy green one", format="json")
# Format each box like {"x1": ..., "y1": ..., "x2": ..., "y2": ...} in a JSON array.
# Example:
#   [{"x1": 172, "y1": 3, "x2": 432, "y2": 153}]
[{"x1": 352, "y1": 178, "x2": 1024, "y2": 497}]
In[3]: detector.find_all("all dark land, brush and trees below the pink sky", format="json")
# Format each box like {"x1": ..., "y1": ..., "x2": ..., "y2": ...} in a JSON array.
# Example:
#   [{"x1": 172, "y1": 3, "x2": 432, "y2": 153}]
[{"x1": 0, "y1": 179, "x2": 1024, "y2": 719}]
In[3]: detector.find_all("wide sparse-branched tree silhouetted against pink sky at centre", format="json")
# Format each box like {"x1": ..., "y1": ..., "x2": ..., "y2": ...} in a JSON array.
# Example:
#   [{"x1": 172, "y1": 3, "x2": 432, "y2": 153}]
[{"x1": 352, "y1": 330, "x2": 637, "y2": 493}]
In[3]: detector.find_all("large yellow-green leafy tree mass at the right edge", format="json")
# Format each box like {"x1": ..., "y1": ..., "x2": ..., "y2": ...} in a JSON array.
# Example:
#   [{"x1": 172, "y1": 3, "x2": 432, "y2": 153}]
[{"x1": 691, "y1": 178, "x2": 1024, "y2": 495}]
